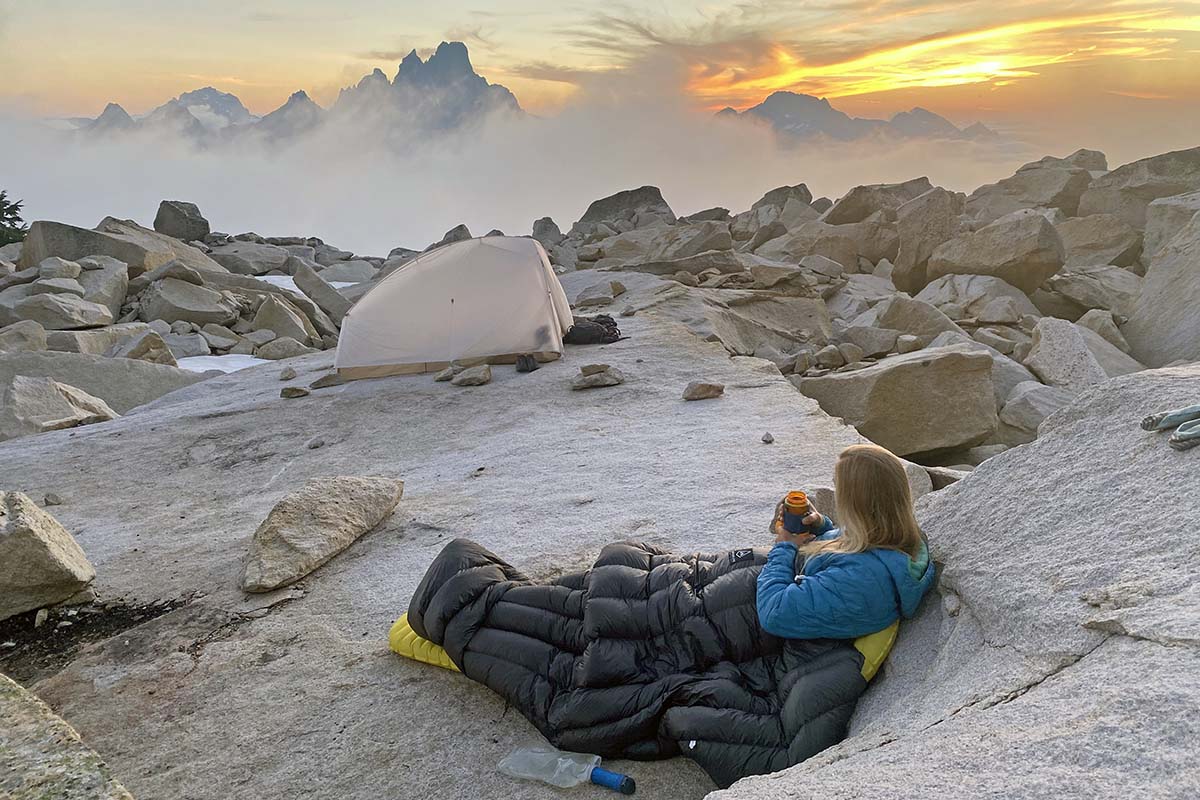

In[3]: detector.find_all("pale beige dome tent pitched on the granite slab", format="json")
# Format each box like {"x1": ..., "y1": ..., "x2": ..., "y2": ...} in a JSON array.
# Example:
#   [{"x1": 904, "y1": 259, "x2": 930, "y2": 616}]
[{"x1": 335, "y1": 236, "x2": 571, "y2": 378}]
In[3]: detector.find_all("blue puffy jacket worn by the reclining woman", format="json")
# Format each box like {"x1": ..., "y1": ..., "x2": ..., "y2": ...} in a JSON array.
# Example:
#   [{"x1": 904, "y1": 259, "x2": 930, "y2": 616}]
[{"x1": 757, "y1": 517, "x2": 934, "y2": 639}]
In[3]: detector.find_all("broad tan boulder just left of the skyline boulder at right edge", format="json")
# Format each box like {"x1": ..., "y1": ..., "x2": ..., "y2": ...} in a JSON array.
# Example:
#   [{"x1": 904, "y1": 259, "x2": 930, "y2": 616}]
[{"x1": 965, "y1": 163, "x2": 1092, "y2": 224}]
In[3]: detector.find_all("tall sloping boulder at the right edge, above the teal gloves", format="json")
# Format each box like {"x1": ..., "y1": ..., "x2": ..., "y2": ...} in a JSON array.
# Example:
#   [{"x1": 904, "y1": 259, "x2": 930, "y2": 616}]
[{"x1": 1121, "y1": 209, "x2": 1200, "y2": 367}]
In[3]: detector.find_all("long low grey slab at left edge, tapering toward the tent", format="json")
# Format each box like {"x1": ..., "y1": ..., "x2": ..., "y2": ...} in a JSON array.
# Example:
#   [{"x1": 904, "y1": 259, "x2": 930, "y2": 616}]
[{"x1": 0, "y1": 350, "x2": 203, "y2": 414}]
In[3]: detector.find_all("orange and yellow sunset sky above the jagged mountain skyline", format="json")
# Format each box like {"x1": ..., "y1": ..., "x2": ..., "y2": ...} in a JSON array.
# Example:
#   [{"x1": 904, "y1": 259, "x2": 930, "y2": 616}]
[{"x1": 0, "y1": 0, "x2": 1200, "y2": 148}]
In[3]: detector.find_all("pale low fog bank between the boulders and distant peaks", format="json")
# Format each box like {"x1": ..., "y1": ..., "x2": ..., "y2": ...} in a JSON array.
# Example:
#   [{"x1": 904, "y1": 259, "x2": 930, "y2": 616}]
[{"x1": 0, "y1": 92, "x2": 1032, "y2": 255}]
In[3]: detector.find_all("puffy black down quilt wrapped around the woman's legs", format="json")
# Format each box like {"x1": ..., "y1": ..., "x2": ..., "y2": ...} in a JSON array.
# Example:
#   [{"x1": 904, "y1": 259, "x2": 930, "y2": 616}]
[{"x1": 408, "y1": 539, "x2": 866, "y2": 788}]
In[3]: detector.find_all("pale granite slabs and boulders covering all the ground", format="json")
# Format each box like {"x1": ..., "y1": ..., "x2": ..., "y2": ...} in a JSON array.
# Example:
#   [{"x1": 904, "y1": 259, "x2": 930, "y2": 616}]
[{"x1": 7, "y1": 148, "x2": 1200, "y2": 800}]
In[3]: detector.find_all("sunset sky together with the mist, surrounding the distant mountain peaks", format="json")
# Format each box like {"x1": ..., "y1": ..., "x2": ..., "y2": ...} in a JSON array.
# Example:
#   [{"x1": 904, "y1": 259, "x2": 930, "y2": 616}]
[{"x1": 0, "y1": 0, "x2": 1200, "y2": 251}]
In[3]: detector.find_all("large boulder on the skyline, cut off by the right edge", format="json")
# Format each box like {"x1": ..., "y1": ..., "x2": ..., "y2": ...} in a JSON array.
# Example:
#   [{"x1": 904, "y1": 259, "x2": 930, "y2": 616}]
[{"x1": 1079, "y1": 148, "x2": 1200, "y2": 229}]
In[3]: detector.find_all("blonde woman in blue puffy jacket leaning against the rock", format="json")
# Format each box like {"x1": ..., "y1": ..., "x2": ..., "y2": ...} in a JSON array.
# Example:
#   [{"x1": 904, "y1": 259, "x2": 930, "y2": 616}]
[{"x1": 756, "y1": 445, "x2": 934, "y2": 639}]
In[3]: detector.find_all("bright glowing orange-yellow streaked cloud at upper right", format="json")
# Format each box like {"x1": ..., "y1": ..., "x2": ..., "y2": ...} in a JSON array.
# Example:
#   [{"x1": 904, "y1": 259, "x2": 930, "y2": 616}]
[{"x1": 686, "y1": 11, "x2": 1185, "y2": 108}]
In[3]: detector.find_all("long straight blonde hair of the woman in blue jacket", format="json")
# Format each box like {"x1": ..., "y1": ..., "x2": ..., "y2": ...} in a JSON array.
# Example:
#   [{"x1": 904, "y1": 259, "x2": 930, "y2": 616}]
[{"x1": 800, "y1": 445, "x2": 922, "y2": 557}]
